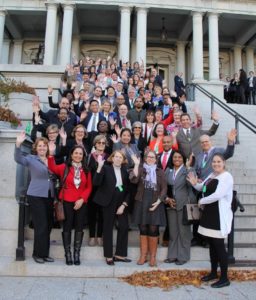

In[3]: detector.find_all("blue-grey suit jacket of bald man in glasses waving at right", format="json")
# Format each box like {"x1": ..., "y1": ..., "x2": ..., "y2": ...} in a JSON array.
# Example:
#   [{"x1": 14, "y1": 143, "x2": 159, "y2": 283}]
[{"x1": 194, "y1": 145, "x2": 235, "y2": 180}]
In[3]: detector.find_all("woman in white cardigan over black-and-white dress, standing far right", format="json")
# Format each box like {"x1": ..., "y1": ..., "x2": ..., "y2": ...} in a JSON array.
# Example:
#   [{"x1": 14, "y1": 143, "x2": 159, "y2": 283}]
[{"x1": 188, "y1": 154, "x2": 233, "y2": 288}]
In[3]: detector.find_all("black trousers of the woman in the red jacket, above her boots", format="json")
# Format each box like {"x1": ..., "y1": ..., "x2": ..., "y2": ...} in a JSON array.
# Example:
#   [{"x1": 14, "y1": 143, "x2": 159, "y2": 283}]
[{"x1": 63, "y1": 201, "x2": 86, "y2": 232}]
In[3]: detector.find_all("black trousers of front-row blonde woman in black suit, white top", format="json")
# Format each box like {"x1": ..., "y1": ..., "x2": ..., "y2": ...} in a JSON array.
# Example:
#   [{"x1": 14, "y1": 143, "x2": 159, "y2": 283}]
[{"x1": 102, "y1": 188, "x2": 129, "y2": 258}]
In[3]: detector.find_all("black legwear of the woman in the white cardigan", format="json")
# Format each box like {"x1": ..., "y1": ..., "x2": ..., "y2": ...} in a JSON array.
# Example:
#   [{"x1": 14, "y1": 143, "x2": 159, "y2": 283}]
[{"x1": 208, "y1": 237, "x2": 228, "y2": 280}]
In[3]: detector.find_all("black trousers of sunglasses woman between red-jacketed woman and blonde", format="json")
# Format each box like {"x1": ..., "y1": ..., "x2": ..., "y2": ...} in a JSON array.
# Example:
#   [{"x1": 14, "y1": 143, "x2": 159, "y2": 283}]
[{"x1": 88, "y1": 198, "x2": 103, "y2": 237}]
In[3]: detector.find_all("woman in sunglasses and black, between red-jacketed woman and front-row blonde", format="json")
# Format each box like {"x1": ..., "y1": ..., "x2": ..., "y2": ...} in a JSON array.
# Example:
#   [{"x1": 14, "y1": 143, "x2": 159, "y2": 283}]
[{"x1": 88, "y1": 134, "x2": 109, "y2": 246}]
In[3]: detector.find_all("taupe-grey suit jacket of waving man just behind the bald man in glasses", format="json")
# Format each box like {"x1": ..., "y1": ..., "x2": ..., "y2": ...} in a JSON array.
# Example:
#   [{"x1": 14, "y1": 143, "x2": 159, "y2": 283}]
[{"x1": 176, "y1": 123, "x2": 219, "y2": 158}]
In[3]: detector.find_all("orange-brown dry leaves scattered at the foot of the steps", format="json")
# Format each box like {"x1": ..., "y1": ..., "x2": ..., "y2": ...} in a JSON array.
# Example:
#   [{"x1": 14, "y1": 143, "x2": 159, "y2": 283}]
[{"x1": 120, "y1": 270, "x2": 256, "y2": 289}]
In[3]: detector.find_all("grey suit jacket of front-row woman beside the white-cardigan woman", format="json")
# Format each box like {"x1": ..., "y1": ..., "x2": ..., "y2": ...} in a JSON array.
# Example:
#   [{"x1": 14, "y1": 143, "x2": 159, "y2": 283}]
[{"x1": 165, "y1": 166, "x2": 196, "y2": 210}]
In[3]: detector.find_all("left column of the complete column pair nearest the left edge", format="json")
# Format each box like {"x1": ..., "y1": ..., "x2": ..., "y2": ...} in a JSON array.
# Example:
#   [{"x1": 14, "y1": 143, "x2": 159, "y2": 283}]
[{"x1": 44, "y1": 3, "x2": 57, "y2": 65}]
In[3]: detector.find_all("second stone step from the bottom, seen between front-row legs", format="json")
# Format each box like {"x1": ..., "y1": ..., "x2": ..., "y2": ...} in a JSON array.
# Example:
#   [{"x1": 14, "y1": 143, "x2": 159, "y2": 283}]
[{"x1": 22, "y1": 241, "x2": 256, "y2": 261}]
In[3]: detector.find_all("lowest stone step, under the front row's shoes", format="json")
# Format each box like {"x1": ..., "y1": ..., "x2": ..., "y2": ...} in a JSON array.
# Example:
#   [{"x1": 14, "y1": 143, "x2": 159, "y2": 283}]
[{"x1": 0, "y1": 257, "x2": 217, "y2": 278}]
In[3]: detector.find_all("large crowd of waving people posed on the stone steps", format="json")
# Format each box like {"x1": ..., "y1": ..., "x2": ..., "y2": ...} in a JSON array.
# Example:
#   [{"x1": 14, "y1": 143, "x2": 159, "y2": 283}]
[{"x1": 15, "y1": 58, "x2": 236, "y2": 287}]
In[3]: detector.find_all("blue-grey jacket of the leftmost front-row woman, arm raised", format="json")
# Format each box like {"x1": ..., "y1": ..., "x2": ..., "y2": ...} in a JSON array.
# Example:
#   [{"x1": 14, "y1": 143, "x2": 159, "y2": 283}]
[{"x1": 14, "y1": 147, "x2": 54, "y2": 198}]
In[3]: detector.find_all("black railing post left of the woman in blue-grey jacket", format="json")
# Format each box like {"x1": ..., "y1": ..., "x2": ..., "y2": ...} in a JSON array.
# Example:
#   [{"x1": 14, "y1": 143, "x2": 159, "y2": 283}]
[{"x1": 16, "y1": 195, "x2": 27, "y2": 261}]
